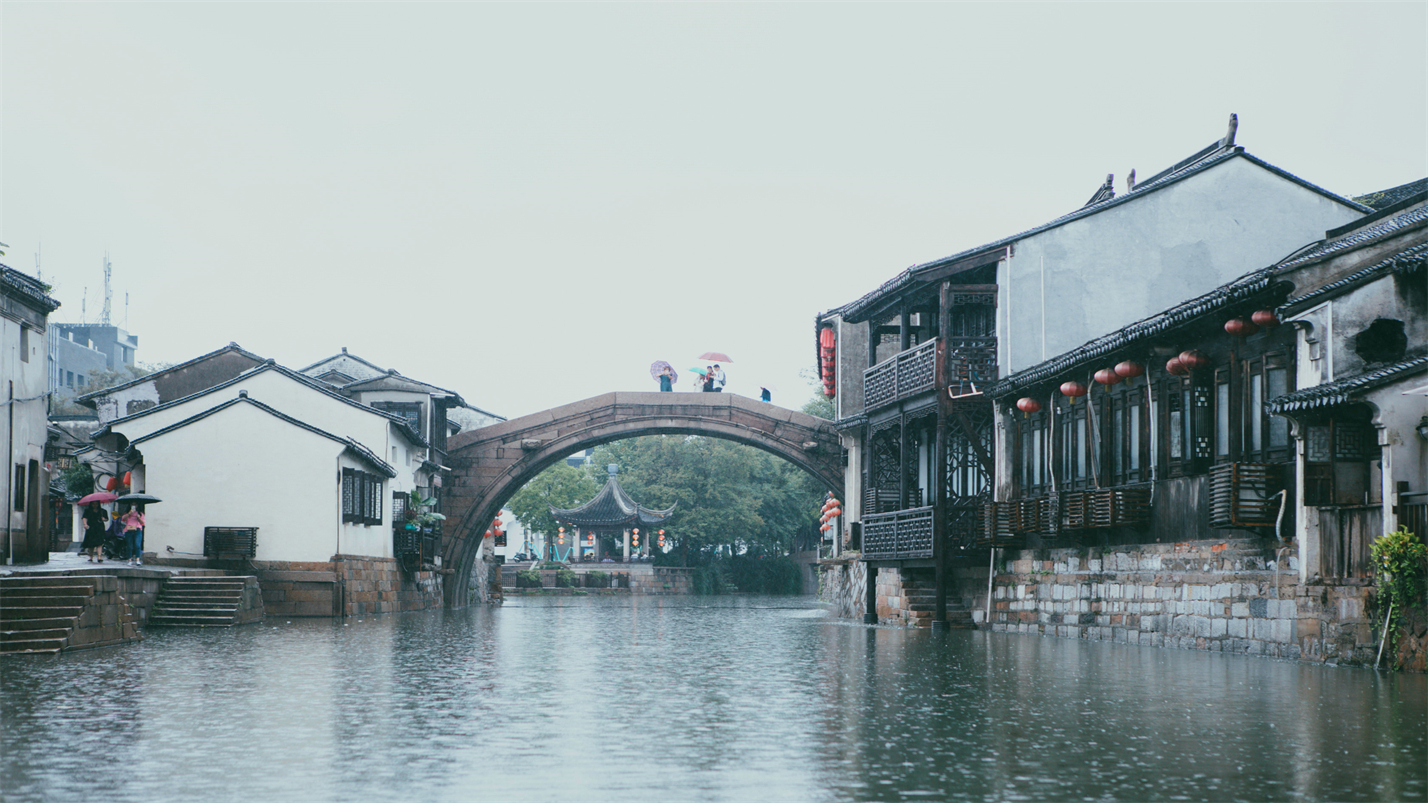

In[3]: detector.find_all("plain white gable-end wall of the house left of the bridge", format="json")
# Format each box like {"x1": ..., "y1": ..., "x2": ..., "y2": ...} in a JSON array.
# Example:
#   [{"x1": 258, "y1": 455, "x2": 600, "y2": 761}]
[{"x1": 140, "y1": 404, "x2": 345, "y2": 562}]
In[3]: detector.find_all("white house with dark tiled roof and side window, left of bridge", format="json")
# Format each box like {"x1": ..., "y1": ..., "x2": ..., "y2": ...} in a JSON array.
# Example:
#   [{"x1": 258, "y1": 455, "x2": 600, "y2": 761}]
[{"x1": 90, "y1": 360, "x2": 436, "y2": 570}]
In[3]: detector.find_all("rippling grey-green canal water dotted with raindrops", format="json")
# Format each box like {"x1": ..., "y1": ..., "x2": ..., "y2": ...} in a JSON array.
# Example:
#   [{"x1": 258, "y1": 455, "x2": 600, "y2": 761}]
[{"x1": 0, "y1": 596, "x2": 1428, "y2": 803}]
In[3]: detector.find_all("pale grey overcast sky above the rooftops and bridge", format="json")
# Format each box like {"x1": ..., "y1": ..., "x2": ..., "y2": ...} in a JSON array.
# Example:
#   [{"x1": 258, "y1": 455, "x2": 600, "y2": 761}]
[{"x1": 0, "y1": 0, "x2": 1428, "y2": 417}]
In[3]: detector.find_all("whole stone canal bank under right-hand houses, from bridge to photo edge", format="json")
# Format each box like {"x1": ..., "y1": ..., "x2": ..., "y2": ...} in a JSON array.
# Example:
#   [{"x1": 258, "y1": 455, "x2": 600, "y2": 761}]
[{"x1": 820, "y1": 539, "x2": 1428, "y2": 673}]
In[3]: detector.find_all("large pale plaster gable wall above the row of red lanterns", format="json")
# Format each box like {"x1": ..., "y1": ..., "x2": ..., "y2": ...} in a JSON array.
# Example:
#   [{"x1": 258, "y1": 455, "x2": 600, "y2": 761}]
[{"x1": 997, "y1": 159, "x2": 1361, "y2": 376}]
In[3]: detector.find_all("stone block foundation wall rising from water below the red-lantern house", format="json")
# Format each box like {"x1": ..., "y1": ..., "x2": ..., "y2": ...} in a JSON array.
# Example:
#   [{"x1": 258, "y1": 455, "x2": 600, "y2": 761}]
[{"x1": 957, "y1": 542, "x2": 1378, "y2": 664}]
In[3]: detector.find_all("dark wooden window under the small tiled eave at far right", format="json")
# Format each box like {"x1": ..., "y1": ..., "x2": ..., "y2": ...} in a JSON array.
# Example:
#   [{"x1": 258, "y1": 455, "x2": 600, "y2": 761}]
[{"x1": 1304, "y1": 404, "x2": 1381, "y2": 507}]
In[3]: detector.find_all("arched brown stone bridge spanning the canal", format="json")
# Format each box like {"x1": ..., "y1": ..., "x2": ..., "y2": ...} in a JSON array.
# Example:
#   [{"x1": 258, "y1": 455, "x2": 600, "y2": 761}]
[{"x1": 441, "y1": 393, "x2": 843, "y2": 607}]
